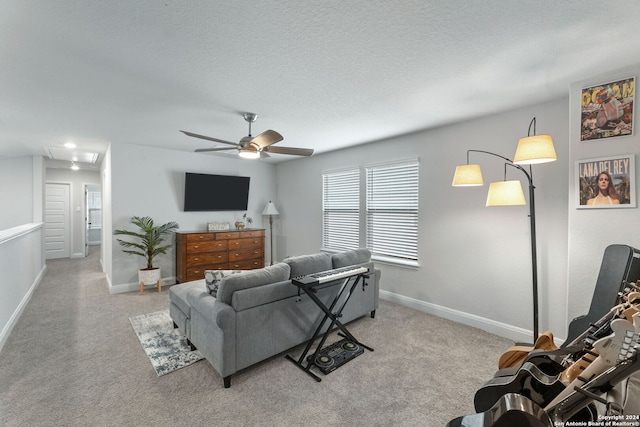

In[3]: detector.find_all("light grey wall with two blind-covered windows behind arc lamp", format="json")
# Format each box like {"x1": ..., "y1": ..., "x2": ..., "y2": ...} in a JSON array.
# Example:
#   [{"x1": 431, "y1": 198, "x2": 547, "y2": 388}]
[{"x1": 276, "y1": 99, "x2": 569, "y2": 341}]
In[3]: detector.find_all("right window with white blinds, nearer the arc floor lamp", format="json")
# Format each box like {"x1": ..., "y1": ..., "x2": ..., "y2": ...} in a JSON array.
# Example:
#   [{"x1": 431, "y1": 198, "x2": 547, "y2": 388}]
[{"x1": 366, "y1": 160, "x2": 419, "y2": 265}]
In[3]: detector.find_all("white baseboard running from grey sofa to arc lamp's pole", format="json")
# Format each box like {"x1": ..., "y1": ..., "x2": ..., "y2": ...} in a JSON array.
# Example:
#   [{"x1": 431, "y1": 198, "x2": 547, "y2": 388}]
[{"x1": 380, "y1": 290, "x2": 533, "y2": 342}]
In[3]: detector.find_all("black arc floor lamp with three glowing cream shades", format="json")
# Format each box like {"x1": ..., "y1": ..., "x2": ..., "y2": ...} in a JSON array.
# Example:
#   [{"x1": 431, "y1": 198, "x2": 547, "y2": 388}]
[{"x1": 452, "y1": 117, "x2": 557, "y2": 343}]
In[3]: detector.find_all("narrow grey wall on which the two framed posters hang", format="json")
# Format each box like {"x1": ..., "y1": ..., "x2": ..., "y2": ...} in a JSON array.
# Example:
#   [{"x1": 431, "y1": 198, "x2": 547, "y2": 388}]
[{"x1": 568, "y1": 65, "x2": 640, "y2": 319}]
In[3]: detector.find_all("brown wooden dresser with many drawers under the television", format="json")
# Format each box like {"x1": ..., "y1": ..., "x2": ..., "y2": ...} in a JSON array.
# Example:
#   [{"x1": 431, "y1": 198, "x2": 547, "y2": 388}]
[{"x1": 176, "y1": 228, "x2": 264, "y2": 283}]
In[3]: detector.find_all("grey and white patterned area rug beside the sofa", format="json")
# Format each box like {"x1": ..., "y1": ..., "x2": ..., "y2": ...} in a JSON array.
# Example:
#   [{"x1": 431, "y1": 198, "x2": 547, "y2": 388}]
[{"x1": 129, "y1": 310, "x2": 203, "y2": 377}]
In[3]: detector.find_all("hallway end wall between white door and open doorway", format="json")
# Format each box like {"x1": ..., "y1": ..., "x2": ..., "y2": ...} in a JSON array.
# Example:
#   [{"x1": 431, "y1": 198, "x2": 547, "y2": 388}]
[{"x1": 46, "y1": 168, "x2": 100, "y2": 258}]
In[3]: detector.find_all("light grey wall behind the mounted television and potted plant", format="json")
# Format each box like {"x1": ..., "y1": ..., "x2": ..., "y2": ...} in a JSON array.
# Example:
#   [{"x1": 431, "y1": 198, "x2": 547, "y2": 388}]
[{"x1": 108, "y1": 143, "x2": 275, "y2": 292}]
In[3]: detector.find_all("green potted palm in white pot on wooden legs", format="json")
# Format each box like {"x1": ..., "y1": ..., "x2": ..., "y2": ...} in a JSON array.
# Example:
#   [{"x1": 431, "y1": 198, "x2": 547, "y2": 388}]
[{"x1": 113, "y1": 216, "x2": 179, "y2": 293}]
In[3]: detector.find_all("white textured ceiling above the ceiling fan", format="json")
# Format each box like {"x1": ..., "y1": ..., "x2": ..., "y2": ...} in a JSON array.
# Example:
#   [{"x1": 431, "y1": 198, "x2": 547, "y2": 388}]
[{"x1": 0, "y1": 0, "x2": 640, "y2": 166}]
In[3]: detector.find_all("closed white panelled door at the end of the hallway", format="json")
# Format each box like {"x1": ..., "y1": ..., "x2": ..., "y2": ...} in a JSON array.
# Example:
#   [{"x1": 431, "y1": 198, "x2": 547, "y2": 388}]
[{"x1": 44, "y1": 184, "x2": 71, "y2": 259}]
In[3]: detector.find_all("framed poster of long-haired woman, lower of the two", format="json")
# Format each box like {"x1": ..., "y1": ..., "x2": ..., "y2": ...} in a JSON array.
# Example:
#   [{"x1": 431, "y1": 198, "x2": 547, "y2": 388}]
[{"x1": 576, "y1": 154, "x2": 636, "y2": 209}]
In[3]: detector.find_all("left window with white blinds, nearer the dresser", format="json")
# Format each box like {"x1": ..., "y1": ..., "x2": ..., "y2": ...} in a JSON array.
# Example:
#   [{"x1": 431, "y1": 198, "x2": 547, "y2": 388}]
[{"x1": 322, "y1": 168, "x2": 360, "y2": 250}]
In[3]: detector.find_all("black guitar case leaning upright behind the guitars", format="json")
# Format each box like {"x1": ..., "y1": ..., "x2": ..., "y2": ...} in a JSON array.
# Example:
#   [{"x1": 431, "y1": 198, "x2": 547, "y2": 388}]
[{"x1": 565, "y1": 245, "x2": 640, "y2": 344}]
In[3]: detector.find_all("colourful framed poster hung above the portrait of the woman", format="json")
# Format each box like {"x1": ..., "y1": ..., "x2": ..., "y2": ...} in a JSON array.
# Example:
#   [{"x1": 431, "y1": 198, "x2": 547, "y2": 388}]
[{"x1": 580, "y1": 77, "x2": 635, "y2": 141}]
